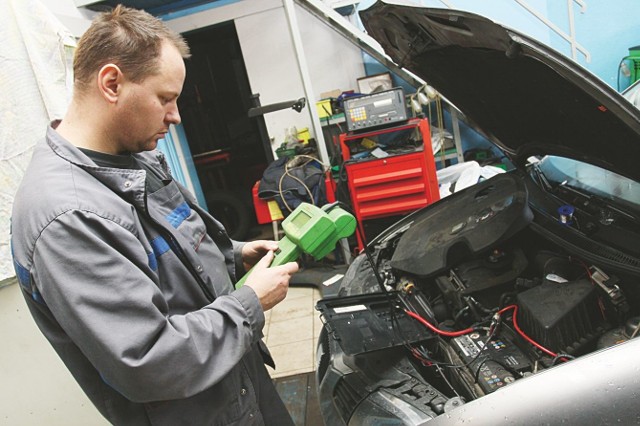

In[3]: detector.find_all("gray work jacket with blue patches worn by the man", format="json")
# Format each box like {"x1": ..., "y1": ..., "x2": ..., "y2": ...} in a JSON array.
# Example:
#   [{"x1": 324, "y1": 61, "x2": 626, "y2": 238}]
[{"x1": 12, "y1": 127, "x2": 273, "y2": 425}]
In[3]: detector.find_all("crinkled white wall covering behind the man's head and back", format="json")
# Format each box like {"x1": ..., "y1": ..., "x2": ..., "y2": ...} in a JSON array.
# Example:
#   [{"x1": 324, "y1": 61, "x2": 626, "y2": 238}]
[{"x1": 0, "y1": 0, "x2": 80, "y2": 281}]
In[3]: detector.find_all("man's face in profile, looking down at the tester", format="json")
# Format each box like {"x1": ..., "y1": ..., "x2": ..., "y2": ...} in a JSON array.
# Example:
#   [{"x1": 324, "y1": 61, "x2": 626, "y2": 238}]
[{"x1": 112, "y1": 42, "x2": 186, "y2": 153}]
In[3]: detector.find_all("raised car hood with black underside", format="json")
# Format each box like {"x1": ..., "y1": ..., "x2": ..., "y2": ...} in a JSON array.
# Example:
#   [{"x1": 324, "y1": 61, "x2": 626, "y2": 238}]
[{"x1": 360, "y1": 1, "x2": 640, "y2": 181}]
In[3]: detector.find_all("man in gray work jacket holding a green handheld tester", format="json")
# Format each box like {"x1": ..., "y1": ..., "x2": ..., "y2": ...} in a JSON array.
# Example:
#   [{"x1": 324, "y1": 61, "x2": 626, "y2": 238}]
[{"x1": 12, "y1": 6, "x2": 298, "y2": 425}]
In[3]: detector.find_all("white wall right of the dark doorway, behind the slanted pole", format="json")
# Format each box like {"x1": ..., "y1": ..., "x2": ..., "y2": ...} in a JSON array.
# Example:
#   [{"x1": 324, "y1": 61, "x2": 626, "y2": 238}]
[{"x1": 167, "y1": 0, "x2": 364, "y2": 156}]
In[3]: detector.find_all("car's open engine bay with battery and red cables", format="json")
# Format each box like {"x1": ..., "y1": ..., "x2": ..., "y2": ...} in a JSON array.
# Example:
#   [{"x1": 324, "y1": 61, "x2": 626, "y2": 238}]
[{"x1": 396, "y1": 241, "x2": 640, "y2": 401}]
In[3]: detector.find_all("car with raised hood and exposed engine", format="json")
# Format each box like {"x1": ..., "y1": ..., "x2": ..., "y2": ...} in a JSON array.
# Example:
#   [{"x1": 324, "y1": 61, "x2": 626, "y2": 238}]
[{"x1": 316, "y1": 2, "x2": 640, "y2": 426}]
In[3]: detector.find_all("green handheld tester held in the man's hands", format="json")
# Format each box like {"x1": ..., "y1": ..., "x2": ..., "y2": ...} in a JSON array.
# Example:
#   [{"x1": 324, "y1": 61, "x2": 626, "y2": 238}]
[{"x1": 236, "y1": 203, "x2": 356, "y2": 288}]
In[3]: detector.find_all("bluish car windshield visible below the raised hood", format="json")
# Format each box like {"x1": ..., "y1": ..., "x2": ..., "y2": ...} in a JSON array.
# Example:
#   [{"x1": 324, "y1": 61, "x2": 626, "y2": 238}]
[{"x1": 538, "y1": 156, "x2": 640, "y2": 212}]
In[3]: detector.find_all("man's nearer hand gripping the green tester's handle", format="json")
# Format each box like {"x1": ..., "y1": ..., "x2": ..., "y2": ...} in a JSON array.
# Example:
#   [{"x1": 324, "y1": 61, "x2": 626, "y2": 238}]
[{"x1": 245, "y1": 251, "x2": 298, "y2": 312}]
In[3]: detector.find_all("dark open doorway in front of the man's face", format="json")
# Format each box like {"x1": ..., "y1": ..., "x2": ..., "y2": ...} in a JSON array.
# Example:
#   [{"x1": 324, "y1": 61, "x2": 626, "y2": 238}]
[{"x1": 178, "y1": 21, "x2": 273, "y2": 240}]
